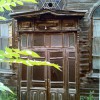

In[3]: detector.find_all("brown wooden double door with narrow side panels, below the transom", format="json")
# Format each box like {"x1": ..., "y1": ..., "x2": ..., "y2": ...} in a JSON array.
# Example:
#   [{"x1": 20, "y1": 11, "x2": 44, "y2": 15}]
[{"x1": 18, "y1": 33, "x2": 79, "y2": 100}]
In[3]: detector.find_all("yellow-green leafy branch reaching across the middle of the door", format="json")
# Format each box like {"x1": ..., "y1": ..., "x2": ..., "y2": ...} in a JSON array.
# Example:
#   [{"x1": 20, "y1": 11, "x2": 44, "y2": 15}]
[{"x1": 0, "y1": 48, "x2": 60, "y2": 70}]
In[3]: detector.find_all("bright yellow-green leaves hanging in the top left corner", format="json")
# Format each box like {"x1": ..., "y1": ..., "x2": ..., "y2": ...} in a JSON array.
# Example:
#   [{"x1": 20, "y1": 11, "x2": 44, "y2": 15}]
[{"x1": 0, "y1": 0, "x2": 37, "y2": 20}]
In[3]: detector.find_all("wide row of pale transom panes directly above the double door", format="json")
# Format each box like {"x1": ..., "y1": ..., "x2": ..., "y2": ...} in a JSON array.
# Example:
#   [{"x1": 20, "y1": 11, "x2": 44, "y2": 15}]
[{"x1": 20, "y1": 32, "x2": 76, "y2": 48}]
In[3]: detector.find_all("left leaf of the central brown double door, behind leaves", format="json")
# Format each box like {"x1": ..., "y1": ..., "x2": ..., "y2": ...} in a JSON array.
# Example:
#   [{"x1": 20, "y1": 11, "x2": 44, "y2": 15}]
[{"x1": 29, "y1": 49, "x2": 47, "y2": 100}]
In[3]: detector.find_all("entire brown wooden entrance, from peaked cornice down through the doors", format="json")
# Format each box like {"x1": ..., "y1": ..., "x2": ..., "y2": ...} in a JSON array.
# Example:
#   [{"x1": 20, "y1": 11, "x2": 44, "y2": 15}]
[{"x1": 12, "y1": 9, "x2": 87, "y2": 100}]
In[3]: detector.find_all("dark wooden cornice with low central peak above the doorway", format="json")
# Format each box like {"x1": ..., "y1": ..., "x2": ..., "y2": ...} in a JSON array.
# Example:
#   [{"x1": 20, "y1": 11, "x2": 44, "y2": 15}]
[{"x1": 10, "y1": 9, "x2": 86, "y2": 18}]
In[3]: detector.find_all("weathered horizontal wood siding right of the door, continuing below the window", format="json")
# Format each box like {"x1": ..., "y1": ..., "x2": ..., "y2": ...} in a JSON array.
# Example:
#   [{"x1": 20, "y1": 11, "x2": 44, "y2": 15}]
[{"x1": 80, "y1": 10, "x2": 100, "y2": 100}]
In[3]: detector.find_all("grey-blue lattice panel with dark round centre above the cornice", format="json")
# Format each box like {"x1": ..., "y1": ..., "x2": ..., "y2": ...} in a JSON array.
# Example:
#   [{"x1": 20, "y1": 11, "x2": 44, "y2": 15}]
[{"x1": 38, "y1": 0, "x2": 66, "y2": 10}]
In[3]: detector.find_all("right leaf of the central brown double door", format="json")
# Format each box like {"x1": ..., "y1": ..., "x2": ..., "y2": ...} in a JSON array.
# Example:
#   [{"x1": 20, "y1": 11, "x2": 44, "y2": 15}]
[{"x1": 48, "y1": 49, "x2": 65, "y2": 100}]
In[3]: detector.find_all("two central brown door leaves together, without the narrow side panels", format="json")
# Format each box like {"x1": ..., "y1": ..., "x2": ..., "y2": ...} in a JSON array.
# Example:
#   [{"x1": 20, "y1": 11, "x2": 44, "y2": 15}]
[{"x1": 30, "y1": 49, "x2": 65, "y2": 100}]
